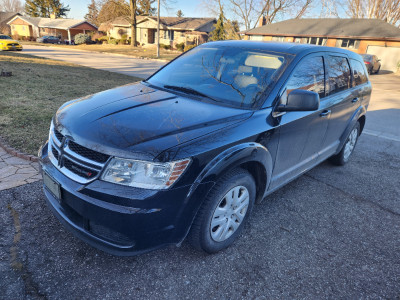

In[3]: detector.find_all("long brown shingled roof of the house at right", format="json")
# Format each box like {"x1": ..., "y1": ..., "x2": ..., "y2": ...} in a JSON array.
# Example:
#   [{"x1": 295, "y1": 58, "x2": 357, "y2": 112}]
[{"x1": 245, "y1": 18, "x2": 400, "y2": 40}]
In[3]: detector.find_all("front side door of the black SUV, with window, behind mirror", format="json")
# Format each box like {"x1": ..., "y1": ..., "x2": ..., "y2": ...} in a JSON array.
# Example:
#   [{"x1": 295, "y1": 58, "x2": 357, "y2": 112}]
[{"x1": 270, "y1": 55, "x2": 330, "y2": 189}]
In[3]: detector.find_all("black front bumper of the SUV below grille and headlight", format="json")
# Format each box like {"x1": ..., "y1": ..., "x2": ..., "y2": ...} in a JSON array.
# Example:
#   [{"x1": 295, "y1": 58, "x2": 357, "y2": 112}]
[{"x1": 40, "y1": 144, "x2": 212, "y2": 256}]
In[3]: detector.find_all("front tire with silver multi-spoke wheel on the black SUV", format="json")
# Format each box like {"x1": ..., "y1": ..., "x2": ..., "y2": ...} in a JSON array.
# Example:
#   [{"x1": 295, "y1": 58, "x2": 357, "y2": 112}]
[{"x1": 188, "y1": 168, "x2": 256, "y2": 253}]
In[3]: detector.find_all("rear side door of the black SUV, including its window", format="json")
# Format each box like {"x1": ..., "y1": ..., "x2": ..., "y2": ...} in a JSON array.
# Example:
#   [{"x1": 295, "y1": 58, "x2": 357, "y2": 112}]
[{"x1": 320, "y1": 53, "x2": 362, "y2": 158}]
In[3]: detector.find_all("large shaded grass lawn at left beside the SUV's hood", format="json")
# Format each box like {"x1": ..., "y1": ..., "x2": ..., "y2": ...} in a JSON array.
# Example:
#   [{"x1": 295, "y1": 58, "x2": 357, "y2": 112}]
[{"x1": 0, "y1": 52, "x2": 140, "y2": 155}]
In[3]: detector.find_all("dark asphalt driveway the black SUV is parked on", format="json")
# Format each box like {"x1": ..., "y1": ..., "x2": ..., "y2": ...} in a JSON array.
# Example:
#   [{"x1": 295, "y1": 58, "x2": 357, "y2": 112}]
[{"x1": 0, "y1": 75, "x2": 400, "y2": 299}]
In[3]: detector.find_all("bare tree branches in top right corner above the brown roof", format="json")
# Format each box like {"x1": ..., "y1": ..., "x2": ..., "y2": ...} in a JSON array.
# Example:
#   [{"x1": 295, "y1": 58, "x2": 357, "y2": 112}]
[{"x1": 345, "y1": 0, "x2": 400, "y2": 26}]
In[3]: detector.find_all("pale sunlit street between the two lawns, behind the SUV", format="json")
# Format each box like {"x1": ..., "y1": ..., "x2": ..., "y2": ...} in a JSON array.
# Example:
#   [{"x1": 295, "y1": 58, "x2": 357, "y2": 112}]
[{"x1": 22, "y1": 45, "x2": 166, "y2": 79}]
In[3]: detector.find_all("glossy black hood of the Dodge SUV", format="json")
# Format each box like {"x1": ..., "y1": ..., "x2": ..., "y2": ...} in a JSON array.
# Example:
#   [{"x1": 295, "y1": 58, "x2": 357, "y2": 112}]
[{"x1": 54, "y1": 83, "x2": 252, "y2": 159}]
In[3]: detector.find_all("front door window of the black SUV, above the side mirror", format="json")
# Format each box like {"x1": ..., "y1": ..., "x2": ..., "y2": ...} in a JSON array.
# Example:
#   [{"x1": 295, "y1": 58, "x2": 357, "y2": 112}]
[{"x1": 286, "y1": 56, "x2": 325, "y2": 98}]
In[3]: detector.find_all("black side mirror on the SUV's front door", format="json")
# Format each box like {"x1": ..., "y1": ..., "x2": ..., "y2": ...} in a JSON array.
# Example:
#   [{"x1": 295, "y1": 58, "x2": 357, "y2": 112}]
[{"x1": 276, "y1": 90, "x2": 319, "y2": 112}]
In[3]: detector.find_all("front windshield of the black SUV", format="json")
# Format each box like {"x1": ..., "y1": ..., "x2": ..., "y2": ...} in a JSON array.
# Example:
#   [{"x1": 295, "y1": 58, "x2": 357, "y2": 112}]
[{"x1": 147, "y1": 45, "x2": 286, "y2": 108}]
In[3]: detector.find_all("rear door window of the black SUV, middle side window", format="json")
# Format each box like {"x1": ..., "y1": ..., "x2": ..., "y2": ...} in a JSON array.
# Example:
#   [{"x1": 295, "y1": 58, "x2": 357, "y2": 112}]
[{"x1": 328, "y1": 56, "x2": 350, "y2": 94}]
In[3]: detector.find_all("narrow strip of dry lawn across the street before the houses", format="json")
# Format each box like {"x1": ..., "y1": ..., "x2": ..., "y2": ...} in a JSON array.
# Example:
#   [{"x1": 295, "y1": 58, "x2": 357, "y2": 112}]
[{"x1": 21, "y1": 41, "x2": 182, "y2": 61}]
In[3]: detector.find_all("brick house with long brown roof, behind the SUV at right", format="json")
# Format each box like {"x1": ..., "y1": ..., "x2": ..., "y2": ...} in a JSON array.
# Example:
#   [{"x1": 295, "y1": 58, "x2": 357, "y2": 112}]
[{"x1": 244, "y1": 18, "x2": 400, "y2": 71}]
